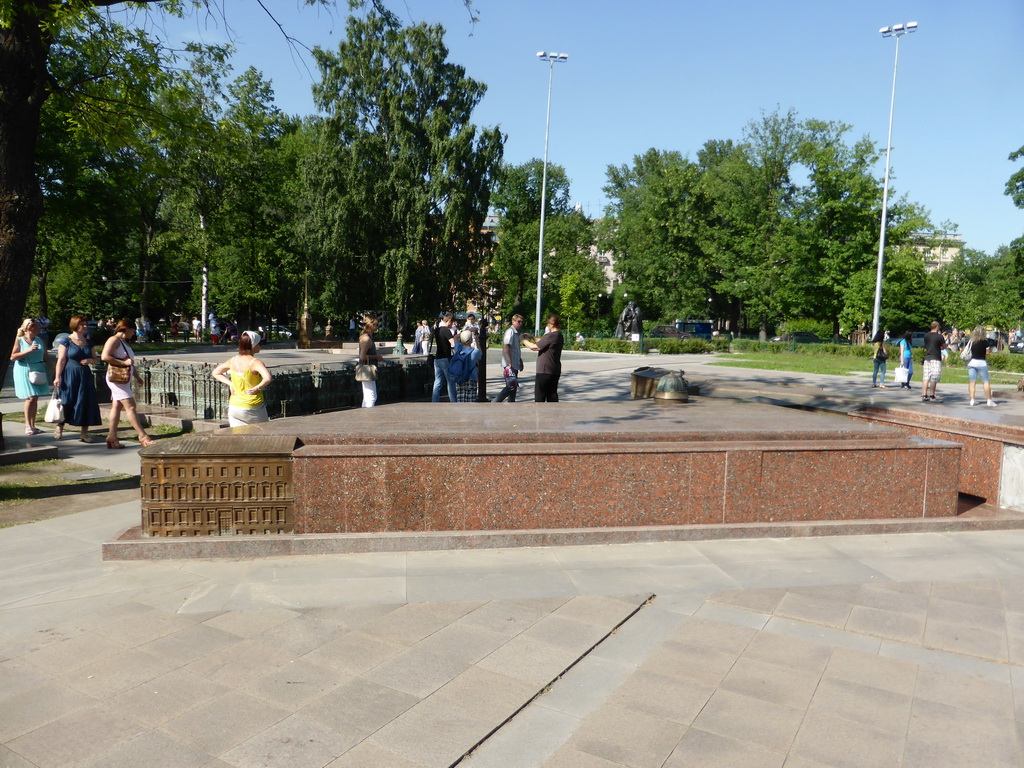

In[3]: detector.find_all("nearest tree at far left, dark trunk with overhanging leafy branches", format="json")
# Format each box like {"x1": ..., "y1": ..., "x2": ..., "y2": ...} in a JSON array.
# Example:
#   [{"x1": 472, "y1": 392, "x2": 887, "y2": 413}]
[{"x1": 0, "y1": 0, "x2": 448, "y2": 397}]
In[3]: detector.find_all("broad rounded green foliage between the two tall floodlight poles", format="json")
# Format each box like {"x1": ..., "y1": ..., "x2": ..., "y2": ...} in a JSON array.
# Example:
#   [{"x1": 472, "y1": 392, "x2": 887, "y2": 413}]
[{"x1": 601, "y1": 111, "x2": 946, "y2": 336}]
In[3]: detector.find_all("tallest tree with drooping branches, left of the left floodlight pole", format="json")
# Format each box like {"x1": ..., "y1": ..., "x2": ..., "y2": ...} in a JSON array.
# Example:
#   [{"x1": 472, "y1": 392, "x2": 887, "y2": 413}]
[{"x1": 303, "y1": 13, "x2": 504, "y2": 325}]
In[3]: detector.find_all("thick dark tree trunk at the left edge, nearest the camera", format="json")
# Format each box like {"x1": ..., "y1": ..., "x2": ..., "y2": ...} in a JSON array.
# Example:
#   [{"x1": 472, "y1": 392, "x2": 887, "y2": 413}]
[{"x1": 0, "y1": 9, "x2": 50, "y2": 450}]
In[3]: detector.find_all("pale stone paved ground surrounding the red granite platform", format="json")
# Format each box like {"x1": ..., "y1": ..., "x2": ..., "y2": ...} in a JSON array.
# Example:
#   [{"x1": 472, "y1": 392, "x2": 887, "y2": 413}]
[{"x1": 0, "y1": 355, "x2": 1024, "y2": 768}]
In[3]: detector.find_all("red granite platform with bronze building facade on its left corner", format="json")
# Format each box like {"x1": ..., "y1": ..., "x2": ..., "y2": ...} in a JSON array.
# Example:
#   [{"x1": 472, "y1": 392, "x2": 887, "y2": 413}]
[{"x1": 141, "y1": 399, "x2": 961, "y2": 537}]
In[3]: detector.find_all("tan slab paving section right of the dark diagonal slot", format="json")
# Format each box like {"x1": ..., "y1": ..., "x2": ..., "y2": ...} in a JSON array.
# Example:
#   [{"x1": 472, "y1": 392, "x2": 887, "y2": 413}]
[{"x1": 469, "y1": 579, "x2": 1024, "y2": 768}]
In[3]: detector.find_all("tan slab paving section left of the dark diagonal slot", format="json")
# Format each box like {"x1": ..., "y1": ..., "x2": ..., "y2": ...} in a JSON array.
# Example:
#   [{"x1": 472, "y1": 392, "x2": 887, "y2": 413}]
[{"x1": 0, "y1": 563, "x2": 646, "y2": 768}]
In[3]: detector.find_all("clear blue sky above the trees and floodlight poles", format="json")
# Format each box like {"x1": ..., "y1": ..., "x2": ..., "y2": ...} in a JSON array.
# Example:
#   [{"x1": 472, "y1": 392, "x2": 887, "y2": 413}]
[{"x1": 163, "y1": 0, "x2": 1024, "y2": 254}]
